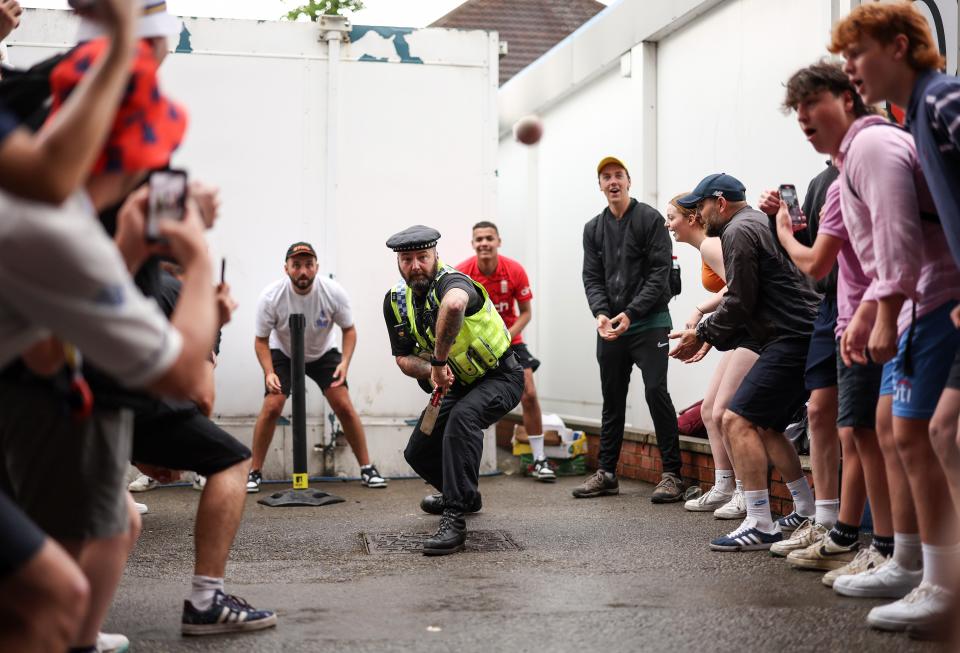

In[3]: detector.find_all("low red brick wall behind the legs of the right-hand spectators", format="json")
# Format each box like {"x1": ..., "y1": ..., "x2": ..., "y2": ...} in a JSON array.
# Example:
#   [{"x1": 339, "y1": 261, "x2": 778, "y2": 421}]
[{"x1": 497, "y1": 415, "x2": 813, "y2": 515}]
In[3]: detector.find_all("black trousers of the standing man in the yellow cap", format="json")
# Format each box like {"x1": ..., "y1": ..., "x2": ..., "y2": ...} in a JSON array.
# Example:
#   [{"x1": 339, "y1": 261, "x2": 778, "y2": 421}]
[{"x1": 597, "y1": 327, "x2": 680, "y2": 476}]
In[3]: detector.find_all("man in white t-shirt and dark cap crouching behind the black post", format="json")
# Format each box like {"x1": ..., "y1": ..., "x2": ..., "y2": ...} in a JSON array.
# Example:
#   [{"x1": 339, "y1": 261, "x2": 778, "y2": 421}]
[{"x1": 247, "y1": 242, "x2": 387, "y2": 492}]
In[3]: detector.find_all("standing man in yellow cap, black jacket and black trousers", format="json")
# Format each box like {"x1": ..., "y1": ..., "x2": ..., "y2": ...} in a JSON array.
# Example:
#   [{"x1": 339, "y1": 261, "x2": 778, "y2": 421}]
[{"x1": 573, "y1": 156, "x2": 683, "y2": 503}]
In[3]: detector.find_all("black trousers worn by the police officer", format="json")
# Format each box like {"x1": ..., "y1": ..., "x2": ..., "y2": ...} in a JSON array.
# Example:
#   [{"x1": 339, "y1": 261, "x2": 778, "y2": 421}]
[{"x1": 403, "y1": 353, "x2": 523, "y2": 510}]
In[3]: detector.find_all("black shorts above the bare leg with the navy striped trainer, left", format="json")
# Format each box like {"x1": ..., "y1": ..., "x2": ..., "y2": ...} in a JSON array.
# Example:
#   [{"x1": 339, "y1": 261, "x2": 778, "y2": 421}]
[{"x1": 130, "y1": 410, "x2": 250, "y2": 476}]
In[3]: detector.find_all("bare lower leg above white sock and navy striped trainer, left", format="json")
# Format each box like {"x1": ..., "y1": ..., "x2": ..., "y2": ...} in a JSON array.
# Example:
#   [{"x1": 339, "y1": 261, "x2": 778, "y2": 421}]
[{"x1": 194, "y1": 461, "x2": 247, "y2": 578}]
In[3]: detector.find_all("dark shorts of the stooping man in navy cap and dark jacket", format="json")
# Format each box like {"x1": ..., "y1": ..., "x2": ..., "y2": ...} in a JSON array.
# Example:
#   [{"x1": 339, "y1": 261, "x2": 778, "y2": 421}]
[{"x1": 727, "y1": 338, "x2": 810, "y2": 432}]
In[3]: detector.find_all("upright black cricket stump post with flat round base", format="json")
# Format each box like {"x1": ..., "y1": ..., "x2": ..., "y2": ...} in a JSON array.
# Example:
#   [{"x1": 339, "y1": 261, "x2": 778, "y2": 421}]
[{"x1": 257, "y1": 313, "x2": 344, "y2": 507}]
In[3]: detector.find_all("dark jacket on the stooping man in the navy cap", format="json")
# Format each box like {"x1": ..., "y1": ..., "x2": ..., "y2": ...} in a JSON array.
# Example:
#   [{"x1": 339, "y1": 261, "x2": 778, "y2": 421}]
[{"x1": 697, "y1": 206, "x2": 822, "y2": 348}]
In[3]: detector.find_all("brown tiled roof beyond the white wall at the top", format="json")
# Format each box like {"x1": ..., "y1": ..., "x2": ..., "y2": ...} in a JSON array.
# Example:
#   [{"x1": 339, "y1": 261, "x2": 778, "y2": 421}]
[{"x1": 430, "y1": 0, "x2": 606, "y2": 85}]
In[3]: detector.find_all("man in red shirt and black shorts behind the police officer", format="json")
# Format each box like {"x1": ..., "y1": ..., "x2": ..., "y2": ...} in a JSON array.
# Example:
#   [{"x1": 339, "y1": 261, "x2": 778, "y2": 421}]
[{"x1": 457, "y1": 221, "x2": 557, "y2": 483}]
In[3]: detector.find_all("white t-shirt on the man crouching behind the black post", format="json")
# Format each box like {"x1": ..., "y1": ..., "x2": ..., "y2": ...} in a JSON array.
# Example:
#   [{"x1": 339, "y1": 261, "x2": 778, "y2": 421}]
[{"x1": 256, "y1": 274, "x2": 353, "y2": 363}]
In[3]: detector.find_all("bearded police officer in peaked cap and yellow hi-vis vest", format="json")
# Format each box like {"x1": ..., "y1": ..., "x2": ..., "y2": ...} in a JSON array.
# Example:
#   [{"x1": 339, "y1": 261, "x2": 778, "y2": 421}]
[{"x1": 383, "y1": 225, "x2": 523, "y2": 555}]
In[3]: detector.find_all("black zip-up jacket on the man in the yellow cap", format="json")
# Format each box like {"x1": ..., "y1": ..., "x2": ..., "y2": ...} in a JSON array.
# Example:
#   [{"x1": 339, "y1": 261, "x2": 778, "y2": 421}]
[{"x1": 583, "y1": 198, "x2": 673, "y2": 322}]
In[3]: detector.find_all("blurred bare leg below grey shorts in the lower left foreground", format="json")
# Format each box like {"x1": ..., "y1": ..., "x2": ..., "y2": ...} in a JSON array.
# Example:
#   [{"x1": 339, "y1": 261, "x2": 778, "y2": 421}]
[{"x1": 63, "y1": 493, "x2": 140, "y2": 647}]
